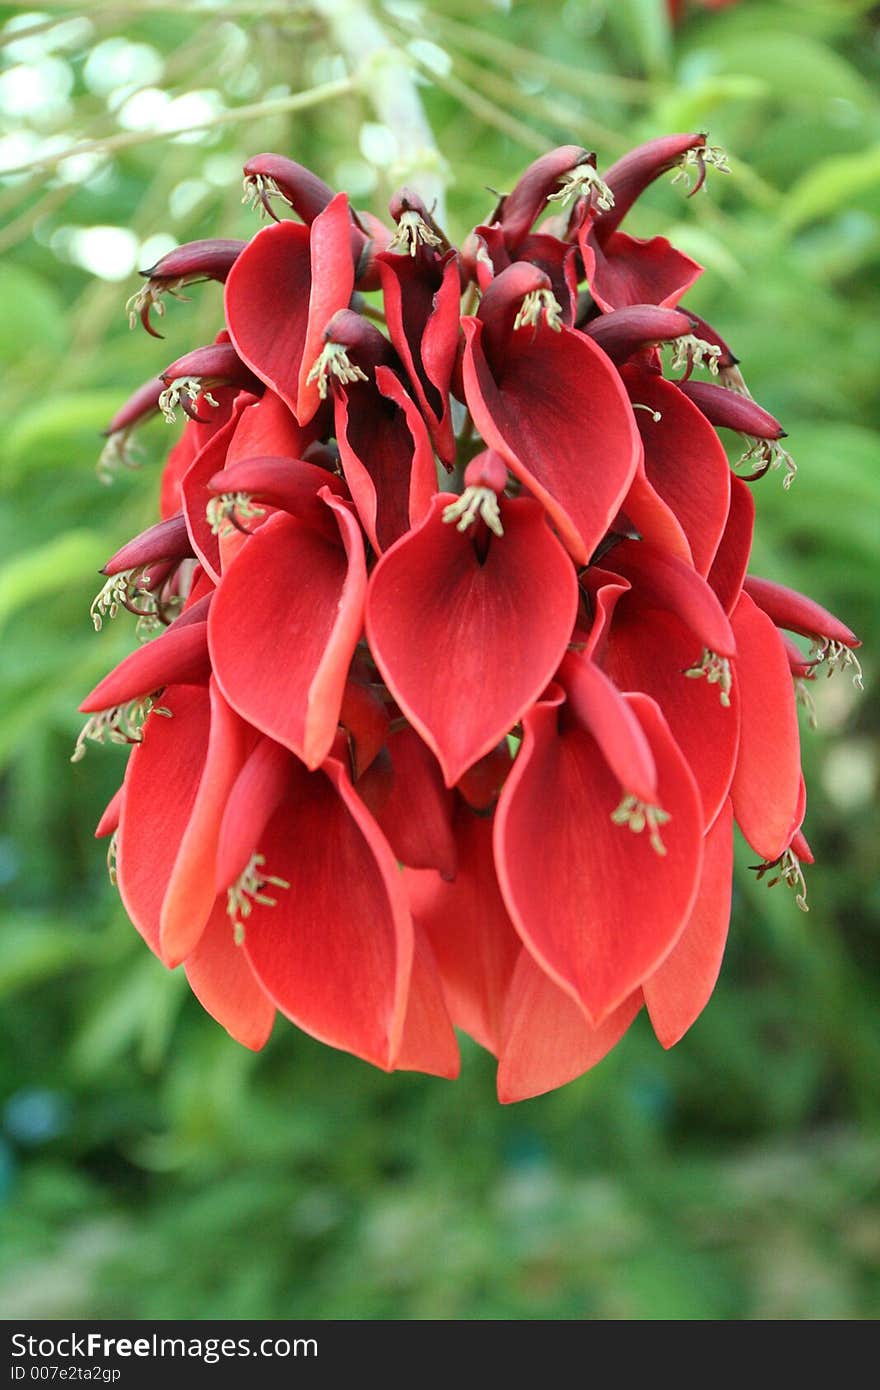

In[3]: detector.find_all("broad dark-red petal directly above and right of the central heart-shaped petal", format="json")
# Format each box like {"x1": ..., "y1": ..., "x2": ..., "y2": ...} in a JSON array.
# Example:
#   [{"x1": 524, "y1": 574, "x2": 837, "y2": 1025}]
[{"x1": 462, "y1": 315, "x2": 641, "y2": 564}]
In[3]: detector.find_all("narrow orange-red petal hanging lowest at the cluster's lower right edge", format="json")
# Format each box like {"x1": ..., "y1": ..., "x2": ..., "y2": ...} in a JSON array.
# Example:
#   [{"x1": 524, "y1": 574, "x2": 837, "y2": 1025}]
[{"x1": 642, "y1": 801, "x2": 733, "y2": 1047}]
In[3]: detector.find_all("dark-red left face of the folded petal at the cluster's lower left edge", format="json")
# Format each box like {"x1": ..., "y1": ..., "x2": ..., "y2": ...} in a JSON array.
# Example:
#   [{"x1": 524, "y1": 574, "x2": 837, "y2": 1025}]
[{"x1": 117, "y1": 685, "x2": 210, "y2": 955}]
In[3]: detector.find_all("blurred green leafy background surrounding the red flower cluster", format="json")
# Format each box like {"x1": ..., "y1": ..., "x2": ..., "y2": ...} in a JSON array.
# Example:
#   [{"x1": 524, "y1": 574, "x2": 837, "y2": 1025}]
[{"x1": 0, "y1": 0, "x2": 880, "y2": 1319}]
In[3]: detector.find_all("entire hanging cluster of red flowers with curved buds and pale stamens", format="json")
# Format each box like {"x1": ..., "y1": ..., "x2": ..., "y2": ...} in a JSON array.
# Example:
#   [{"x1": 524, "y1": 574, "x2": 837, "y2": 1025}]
[{"x1": 75, "y1": 135, "x2": 858, "y2": 1101}]
